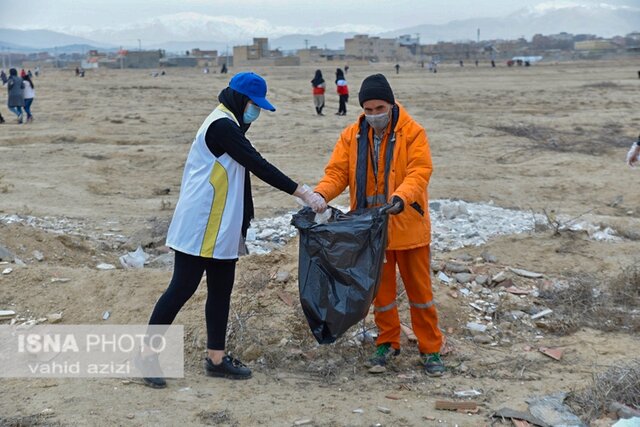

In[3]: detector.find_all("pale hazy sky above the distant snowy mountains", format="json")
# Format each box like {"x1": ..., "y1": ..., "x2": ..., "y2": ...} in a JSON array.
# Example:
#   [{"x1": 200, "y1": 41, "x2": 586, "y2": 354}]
[{"x1": 0, "y1": 0, "x2": 640, "y2": 30}]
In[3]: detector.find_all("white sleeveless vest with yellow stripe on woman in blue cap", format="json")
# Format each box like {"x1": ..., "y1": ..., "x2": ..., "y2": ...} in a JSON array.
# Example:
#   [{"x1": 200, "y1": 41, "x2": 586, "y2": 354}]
[{"x1": 167, "y1": 104, "x2": 245, "y2": 259}]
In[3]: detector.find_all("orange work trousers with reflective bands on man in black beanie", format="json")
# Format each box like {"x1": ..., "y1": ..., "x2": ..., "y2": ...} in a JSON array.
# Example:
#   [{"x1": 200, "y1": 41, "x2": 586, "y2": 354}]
[{"x1": 373, "y1": 246, "x2": 442, "y2": 353}]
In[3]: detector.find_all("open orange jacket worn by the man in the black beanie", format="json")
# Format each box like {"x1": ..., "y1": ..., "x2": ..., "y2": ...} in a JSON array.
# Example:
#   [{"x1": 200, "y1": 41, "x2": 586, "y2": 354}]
[{"x1": 315, "y1": 104, "x2": 433, "y2": 250}]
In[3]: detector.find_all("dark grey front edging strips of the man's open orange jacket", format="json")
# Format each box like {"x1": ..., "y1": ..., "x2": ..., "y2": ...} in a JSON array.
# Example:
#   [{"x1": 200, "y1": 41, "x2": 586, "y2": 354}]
[{"x1": 356, "y1": 105, "x2": 398, "y2": 209}]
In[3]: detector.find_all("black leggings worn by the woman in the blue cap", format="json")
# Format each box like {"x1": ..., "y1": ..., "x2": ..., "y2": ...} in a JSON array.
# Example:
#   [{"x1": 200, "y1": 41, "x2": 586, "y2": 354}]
[{"x1": 149, "y1": 251, "x2": 237, "y2": 350}]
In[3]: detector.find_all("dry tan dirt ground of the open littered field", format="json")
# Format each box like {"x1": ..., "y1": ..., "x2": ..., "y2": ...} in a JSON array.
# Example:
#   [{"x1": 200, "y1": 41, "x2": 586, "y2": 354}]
[{"x1": 0, "y1": 59, "x2": 640, "y2": 426}]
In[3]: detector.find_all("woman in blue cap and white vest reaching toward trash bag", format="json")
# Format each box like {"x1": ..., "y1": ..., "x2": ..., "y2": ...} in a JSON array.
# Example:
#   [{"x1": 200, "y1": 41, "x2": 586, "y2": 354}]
[{"x1": 139, "y1": 72, "x2": 326, "y2": 388}]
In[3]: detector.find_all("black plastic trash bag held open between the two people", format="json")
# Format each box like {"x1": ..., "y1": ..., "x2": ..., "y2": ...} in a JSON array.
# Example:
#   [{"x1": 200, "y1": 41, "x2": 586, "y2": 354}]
[{"x1": 291, "y1": 208, "x2": 388, "y2": 344}]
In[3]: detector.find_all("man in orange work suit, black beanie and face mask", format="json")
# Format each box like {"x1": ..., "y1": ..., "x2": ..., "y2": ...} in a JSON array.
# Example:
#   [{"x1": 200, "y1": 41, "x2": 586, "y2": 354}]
[{"x1": 315, "y1": 74, "x2": 445, "y2": 376}]
